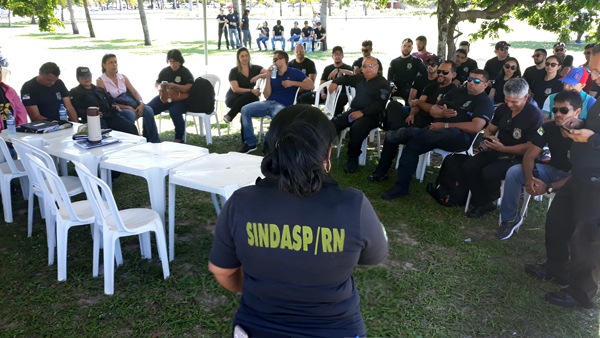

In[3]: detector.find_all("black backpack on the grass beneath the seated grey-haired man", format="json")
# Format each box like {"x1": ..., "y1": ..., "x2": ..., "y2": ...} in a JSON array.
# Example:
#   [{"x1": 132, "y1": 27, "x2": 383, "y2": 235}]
[{"x1": 427, "y1": 154, "x2": 469, "y2": 207}]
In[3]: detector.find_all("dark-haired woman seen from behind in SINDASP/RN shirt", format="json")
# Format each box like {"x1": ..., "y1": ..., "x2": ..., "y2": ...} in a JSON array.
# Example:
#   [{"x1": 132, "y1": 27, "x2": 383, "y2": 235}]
[{"x1": 209, "y1": 105, "x2": 388, "y2": 338}]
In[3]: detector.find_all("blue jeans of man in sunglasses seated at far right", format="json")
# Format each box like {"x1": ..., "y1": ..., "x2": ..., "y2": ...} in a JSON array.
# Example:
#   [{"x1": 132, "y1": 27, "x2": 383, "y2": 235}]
[{"x1": 500, "y1": 163, "x2": 571, "y2": 222}]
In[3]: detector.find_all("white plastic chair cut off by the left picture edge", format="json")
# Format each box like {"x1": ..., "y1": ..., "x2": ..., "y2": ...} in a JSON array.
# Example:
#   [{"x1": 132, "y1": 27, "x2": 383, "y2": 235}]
[{"x1": 0, "y1": 137, "x2": 29, "y2": 223}]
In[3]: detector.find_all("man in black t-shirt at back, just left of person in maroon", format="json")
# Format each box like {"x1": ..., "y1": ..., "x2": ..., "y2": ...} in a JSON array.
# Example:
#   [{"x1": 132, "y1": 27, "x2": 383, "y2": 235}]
[{"x1": 387, "y1": 39, "x2": 427, "y2": 100}]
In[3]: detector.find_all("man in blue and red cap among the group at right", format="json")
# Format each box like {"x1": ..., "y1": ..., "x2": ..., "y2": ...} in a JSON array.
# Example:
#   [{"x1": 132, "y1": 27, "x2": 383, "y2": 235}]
[{"x1": 542, "y1": 68, "x2": 596, "y2": 122}]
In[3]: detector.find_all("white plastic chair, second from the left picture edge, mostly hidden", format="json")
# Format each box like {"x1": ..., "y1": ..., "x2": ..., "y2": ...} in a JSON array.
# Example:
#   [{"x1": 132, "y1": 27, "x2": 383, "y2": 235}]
[{"x1": 12, "y1": 139, "x2": 83, "y2": 239}]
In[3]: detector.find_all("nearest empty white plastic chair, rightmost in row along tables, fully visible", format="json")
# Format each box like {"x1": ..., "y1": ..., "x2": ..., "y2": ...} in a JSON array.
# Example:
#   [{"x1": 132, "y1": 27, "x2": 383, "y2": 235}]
[{"x1": 73, "y1": 161, "x2": 170, "y2": 295}]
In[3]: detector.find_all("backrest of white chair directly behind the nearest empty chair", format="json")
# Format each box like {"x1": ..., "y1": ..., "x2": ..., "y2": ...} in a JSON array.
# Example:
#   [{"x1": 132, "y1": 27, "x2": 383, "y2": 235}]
[{"x1": 25, "y1": 154, "x2": 84, "y2": 222}]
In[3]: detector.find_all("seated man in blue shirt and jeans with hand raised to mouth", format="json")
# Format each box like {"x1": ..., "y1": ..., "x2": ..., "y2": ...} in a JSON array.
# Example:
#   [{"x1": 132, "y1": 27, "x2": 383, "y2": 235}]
[{"x1": 239, "y1": 50, "x2": 315, "y2": 153}]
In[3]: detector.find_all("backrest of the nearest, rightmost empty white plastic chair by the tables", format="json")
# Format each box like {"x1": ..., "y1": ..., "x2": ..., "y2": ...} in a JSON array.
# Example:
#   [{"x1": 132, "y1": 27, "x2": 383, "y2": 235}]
[{"x1": 72, "y1": 161, "x2": 129, "y2": 232}]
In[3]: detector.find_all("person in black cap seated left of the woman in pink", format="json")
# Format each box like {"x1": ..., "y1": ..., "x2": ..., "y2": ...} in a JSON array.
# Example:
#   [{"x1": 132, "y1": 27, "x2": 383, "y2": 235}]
[{"x1": 70, "y1": 67, "x2": 139, "y2": 135}]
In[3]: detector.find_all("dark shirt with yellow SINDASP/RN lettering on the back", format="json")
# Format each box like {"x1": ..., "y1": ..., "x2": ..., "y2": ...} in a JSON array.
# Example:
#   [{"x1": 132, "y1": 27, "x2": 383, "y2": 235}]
[{"x1": 210, "y1": 175, "x2": 388, "y2": 337}]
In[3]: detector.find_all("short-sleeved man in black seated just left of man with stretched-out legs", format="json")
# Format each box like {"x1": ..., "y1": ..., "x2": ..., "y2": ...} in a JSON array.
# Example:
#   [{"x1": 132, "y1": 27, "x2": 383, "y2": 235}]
[{"x1": 368, "y1": 61, "x2": 456, "y2": 182}]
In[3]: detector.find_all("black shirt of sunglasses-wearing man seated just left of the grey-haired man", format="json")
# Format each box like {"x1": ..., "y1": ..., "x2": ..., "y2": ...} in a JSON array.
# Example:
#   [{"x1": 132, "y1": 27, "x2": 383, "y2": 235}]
[{"x1": 434, "y1": 87, "x2": 494, "y2": 129}]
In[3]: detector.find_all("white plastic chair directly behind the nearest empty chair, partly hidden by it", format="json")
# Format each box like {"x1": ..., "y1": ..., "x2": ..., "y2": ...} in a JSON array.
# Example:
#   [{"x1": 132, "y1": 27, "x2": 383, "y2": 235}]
[{"x1": 25, "y1": 154, "x2": 94, "y2": 281}]
